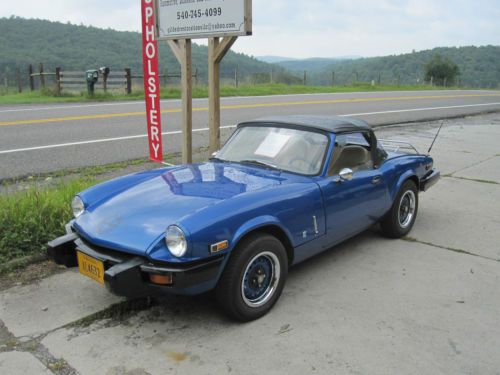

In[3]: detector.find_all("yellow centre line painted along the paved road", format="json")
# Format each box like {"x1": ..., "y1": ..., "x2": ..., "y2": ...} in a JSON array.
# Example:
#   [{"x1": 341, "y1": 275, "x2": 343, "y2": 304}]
[{"x1": 0, "y1": 90, "x2": 487, "y2": 113}]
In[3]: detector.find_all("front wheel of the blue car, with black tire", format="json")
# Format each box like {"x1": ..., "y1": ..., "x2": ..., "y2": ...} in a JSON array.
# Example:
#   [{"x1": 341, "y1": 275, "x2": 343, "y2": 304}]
[{"x1": 215, "y1": 233, "x2": 288, "y2": 322}]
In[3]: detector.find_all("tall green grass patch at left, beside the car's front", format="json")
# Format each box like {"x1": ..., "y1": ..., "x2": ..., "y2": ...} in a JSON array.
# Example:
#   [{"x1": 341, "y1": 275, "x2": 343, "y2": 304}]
[{"x1": 0, "y1": 177, "x2": 96, "y2": 263}]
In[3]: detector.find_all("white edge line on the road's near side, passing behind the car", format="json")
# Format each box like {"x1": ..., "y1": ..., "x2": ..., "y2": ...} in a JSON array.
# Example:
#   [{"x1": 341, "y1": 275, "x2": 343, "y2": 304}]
[{"x1": 0, "y1": 103, "x2": 500, "y2": 155}]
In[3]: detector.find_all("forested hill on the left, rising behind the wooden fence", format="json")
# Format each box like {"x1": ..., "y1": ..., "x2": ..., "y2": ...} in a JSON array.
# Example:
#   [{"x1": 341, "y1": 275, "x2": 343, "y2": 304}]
[{"x1": 0, "y1": 17, "x2": 292, "y2": 81}]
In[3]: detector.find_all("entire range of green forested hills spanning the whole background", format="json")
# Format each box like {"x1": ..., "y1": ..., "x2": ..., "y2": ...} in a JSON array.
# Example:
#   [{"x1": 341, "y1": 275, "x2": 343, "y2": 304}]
[{"x1": 0, "y1": 17, "x2": 500, "y2": 88}]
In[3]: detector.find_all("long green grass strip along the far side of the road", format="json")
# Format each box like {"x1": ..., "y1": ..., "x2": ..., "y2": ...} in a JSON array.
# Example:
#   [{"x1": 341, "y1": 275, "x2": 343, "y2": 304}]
[{"x1": 0, "y1": 82, "x2": 460, "y2": 104}]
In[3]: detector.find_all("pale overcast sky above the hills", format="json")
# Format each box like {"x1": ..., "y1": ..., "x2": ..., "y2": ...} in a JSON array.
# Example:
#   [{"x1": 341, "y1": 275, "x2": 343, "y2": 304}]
[{"x1": 0, "y1": 0, "x2": 500, "y2": 58}]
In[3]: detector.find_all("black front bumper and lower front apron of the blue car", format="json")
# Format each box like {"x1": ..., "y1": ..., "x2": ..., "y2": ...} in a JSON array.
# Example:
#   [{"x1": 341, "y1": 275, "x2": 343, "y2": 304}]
[{"x1": 48, "y1": 228, "x2": 224, "y2": 298}]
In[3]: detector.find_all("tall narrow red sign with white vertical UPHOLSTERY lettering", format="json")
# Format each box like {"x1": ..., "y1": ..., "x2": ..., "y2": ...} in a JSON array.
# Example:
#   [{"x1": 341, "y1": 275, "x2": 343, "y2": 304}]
[{"x1": 141, "y1": 0, "x2": 163, "y2": 163}]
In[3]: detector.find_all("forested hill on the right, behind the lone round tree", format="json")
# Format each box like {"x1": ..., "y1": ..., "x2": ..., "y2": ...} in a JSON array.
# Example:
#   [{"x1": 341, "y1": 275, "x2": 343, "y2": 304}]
[{"x1": 279, "y1": 46, "x2": 500, "y2": 88}]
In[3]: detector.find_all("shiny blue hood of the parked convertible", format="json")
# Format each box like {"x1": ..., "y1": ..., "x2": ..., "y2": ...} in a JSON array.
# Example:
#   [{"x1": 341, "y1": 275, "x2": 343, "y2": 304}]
[{"x1": 73, "y1": 163, "x2": 294, "y2": 255}]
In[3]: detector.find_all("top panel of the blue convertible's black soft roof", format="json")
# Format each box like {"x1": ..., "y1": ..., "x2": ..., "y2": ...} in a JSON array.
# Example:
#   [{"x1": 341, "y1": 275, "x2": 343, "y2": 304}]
[{"x1": 238, "y1": 115, "x2": 371, "y2": 137}]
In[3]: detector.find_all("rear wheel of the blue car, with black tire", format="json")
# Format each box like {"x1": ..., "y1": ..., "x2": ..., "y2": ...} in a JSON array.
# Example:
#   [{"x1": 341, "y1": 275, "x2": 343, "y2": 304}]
[{"x1": 380, "y1": 180, "x2": 418, "y2": 238}]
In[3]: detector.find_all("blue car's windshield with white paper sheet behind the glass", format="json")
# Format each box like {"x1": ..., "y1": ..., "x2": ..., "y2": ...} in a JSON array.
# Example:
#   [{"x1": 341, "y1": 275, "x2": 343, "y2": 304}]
[{"x1": 216, "y1": 126, "x2": 328, "y2": 175}]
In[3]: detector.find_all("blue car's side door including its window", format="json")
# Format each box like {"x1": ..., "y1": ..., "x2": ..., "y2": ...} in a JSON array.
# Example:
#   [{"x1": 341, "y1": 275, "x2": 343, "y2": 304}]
[{"x1": 320, "y1": 132, "x2": 389, "y2": 245}]
